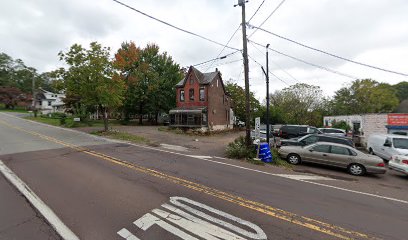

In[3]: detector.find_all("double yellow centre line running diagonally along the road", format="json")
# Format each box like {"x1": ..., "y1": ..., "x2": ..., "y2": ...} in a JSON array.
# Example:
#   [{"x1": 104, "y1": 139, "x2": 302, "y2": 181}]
[{"x1": 0, "y1": 120, "x2": 376, "y2": 239}]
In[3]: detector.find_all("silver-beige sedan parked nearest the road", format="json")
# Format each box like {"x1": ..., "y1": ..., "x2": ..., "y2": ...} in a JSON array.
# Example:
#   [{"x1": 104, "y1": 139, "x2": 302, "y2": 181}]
[{"x1": 279, "y1": 142, "x2": 386, "y2": 176}]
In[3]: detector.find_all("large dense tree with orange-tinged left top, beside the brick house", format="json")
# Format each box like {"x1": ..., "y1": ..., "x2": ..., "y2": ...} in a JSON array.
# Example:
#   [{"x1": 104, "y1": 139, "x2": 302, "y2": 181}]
[{"x1": 114, "y1": 42, "x2": 183, "y2": 124}]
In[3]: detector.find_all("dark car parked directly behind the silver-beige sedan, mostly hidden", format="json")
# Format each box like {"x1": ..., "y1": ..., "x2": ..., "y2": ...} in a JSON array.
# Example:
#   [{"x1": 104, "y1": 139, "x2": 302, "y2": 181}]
[{"x1": 277, "y1": 134, "x2": 354, "y2": 147}]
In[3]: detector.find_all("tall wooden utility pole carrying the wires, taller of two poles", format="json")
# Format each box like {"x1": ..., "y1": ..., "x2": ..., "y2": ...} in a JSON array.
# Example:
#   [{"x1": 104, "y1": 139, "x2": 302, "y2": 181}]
[{"x1": 235, "y1": 0, "x2": 251, "y2": 146}]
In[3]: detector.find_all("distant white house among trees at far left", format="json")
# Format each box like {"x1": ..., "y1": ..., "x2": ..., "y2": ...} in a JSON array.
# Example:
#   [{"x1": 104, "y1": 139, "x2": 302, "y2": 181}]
[{"x1": 35, "y1": 88, "x2": 65, "y2": 114}]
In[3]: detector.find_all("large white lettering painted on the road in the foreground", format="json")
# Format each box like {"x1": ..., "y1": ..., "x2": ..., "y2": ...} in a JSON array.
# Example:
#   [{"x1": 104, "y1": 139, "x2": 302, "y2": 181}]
[{"x1": 118, "y1": 197, "x2": 267, "y2": 240}]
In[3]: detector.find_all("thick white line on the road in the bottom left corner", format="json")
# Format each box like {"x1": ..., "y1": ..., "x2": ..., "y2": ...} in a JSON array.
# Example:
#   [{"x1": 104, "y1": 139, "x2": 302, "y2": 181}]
[{"x1": 0, "y1": 160, "x2": 79, "y2": 240}]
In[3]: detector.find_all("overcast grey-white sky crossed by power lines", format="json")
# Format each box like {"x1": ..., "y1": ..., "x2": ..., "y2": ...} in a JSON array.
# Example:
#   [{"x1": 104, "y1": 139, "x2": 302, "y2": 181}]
[{"x1": 0, "y1": 0, "x2": 408, "y2": 101}]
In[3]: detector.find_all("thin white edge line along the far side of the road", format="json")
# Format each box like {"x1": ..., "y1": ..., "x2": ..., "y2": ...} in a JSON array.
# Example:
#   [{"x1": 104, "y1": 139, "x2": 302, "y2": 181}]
[{"x1": 0, "y1": 113, "x2": 408, "y2": 204}]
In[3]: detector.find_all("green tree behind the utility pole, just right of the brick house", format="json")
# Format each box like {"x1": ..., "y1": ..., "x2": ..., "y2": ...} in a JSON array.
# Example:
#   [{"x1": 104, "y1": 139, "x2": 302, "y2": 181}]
[{"x1": 224, "y1": 80, "x2": 264, "y2": 124}]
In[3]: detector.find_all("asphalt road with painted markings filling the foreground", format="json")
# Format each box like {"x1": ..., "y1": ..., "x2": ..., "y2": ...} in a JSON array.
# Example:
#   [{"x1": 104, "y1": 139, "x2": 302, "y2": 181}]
[{"x1": 0, "y1": 113, "x2": 408, "y2": 239}]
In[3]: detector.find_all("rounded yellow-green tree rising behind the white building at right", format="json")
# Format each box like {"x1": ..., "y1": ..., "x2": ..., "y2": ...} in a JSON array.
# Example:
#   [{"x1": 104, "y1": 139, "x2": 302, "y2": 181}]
[{"x1": 333, "y1": 79, "x2": 399, "y2": 115}]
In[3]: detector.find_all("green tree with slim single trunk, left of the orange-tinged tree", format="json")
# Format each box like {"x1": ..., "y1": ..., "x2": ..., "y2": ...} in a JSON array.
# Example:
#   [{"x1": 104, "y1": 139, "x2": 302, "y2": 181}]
[{"x1": 58, "y1": 42, "x2": 124, "y2": 131}]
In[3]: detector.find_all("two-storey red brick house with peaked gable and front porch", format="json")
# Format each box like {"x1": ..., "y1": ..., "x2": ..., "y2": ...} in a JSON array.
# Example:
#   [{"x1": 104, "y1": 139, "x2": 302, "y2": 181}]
[{"x1": 169, "y1": 66, "x2": 234, "y2": 131}]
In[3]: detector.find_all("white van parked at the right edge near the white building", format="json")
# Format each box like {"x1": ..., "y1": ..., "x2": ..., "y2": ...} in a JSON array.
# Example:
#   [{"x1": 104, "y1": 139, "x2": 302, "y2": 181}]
[{"x1": 367, "y1": 134, "x2": 408, "y2": 161}]
